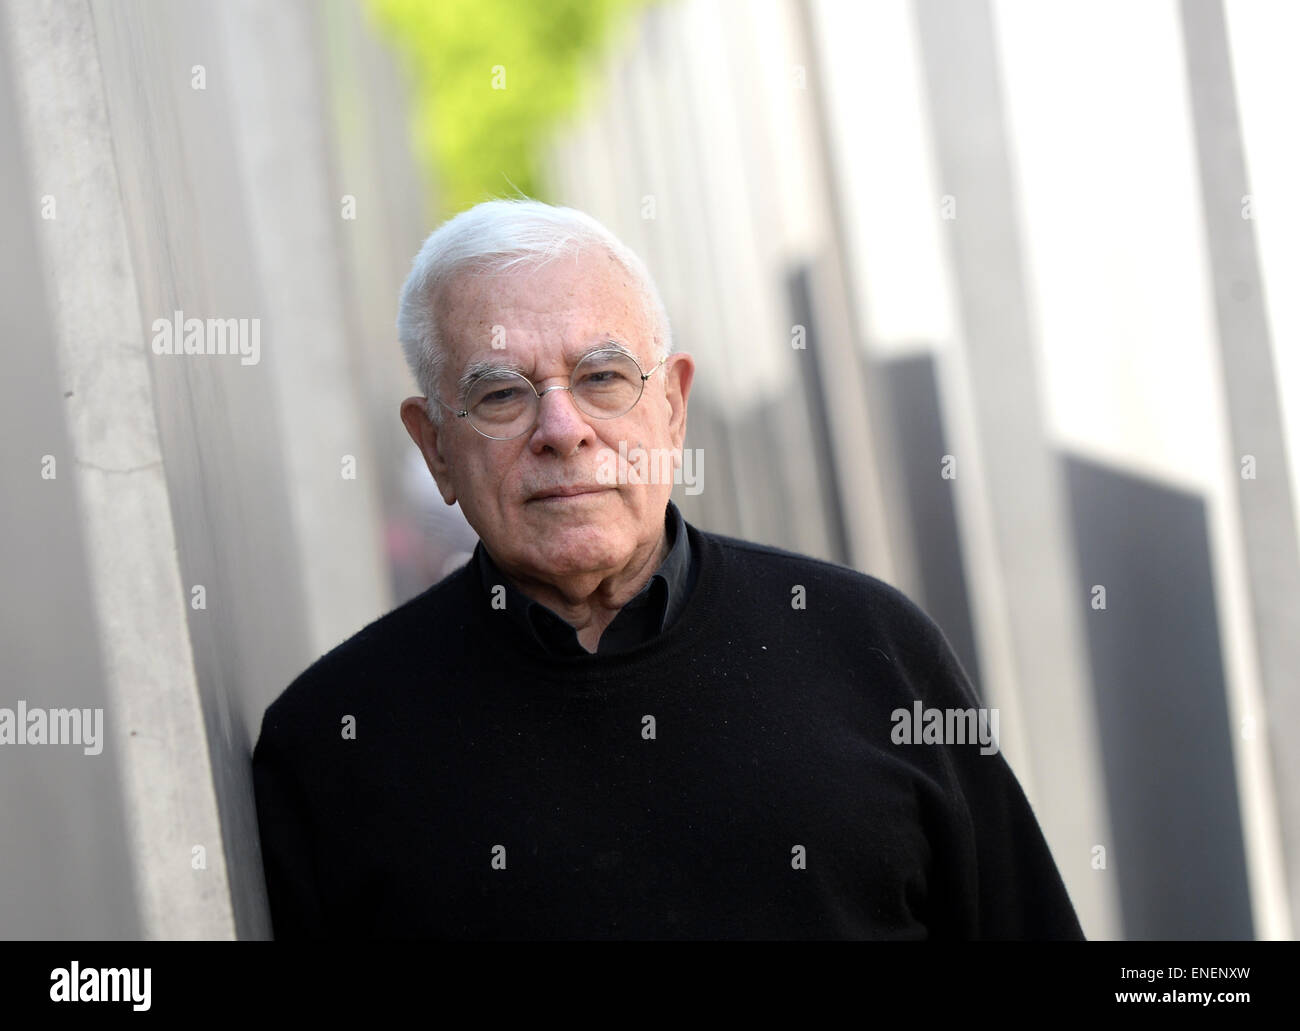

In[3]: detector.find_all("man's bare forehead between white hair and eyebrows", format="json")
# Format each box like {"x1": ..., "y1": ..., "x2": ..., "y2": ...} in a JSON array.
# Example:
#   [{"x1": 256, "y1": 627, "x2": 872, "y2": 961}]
[{"x1": 438, "y1": 251, "x2": 654, "y2": 365}]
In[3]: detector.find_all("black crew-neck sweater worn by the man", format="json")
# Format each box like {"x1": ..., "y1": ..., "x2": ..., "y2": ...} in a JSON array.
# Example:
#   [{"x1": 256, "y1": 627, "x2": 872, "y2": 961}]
[{"x1": 254, "y1": 524, "x2": 1083, "y2": 939}]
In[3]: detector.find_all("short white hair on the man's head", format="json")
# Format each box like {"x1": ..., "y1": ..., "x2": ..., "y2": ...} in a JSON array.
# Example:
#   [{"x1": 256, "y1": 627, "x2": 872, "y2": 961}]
[{"x1": 398, "y1": 198, "x2": 672, "y2": 423}]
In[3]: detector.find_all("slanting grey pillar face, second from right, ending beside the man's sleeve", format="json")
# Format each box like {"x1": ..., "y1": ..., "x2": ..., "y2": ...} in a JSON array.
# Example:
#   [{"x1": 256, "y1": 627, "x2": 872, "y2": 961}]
[{"x1": 915, "y1": 0, "x2": 1119, "y2": 939}]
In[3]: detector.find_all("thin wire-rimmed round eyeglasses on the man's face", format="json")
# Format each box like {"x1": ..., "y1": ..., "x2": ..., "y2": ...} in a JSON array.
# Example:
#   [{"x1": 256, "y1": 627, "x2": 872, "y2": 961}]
[{"x1": 433, "y1": 348, "x2": 668, "y2": 441}]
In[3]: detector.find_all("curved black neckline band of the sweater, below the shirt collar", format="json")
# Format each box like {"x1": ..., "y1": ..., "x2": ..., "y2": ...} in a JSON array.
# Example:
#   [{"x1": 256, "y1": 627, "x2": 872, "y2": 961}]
[{"x1": 465, "y1": 523, "x2": 724, "y2": 683}]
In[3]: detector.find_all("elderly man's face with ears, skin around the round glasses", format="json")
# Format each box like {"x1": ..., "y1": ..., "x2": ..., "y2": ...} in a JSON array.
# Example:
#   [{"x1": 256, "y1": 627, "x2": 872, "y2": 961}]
[{"x1": 402, "y1": 250, "x2": 694, "y2": 584}]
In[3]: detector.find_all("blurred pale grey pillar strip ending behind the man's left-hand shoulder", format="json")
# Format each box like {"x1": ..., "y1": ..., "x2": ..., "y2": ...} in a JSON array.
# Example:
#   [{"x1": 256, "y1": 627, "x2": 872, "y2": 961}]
[{"x1": 220, "y1": 0, "x2": 395, "y2": 654}]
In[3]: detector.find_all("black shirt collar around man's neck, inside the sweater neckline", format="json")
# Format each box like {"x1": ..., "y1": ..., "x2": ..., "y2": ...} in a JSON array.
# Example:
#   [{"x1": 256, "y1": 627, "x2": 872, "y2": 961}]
[{"x1": 473, "y1": 501, "x2": 697, "y2": 655}]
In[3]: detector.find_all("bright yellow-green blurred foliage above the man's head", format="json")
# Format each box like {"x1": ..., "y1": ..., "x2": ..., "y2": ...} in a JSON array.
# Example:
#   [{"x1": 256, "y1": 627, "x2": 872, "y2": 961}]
[{"x1": 367, "y1": 0, "x2": 646, "y2": 215}]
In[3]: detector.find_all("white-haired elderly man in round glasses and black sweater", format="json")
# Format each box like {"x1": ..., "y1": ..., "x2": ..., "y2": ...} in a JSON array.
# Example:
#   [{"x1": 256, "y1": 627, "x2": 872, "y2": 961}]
[{"x1": 254, "y1": 200, "x2": 1082, "y2": 939}]
